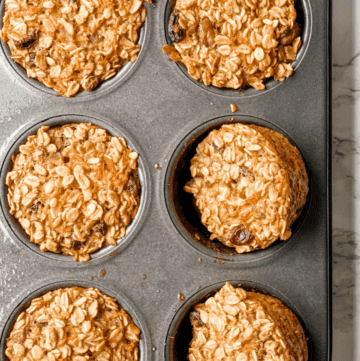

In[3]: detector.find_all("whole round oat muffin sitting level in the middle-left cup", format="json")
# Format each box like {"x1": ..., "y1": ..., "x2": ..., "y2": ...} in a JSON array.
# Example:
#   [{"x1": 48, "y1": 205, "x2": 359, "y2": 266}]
[{"x1": 6, "y1": 123, "x2": 140, "y2": 262}]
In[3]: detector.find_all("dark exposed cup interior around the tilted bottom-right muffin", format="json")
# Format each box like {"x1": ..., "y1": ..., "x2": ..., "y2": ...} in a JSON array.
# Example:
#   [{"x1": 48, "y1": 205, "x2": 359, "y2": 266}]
[{"x1": 165, "y1": 280, "x2": 313, "y2": 361}]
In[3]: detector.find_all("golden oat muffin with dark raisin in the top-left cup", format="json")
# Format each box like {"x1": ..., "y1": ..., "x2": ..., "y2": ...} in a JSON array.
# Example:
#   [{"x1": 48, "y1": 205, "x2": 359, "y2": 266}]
[{"x1": 1, "y1": 0, "x2": 146, "y2": 97}]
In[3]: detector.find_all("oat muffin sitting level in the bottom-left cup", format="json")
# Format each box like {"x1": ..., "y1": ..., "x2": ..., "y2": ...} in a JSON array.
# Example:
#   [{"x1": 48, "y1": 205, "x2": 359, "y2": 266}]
[{"x1": 5, "y1": 287, "x2": 140, "y2": 361}]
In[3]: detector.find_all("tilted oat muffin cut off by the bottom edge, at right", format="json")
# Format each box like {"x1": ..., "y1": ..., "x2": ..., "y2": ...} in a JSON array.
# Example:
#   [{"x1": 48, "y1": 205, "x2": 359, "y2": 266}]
[{"x1": 188, "y1": 282, "x2": 308, "y2": 361}]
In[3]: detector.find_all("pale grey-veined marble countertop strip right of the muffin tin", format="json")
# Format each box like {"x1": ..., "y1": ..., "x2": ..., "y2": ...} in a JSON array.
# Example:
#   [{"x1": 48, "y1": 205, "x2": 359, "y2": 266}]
[{"x1": 333, "y1": 0, "x2": 360, "y2": 361}]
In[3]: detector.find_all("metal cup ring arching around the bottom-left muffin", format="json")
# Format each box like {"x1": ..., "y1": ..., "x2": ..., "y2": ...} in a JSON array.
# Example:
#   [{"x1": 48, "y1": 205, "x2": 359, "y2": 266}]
[{"x1": 0, "y1": 280, "x2": 151, "y2": 361}]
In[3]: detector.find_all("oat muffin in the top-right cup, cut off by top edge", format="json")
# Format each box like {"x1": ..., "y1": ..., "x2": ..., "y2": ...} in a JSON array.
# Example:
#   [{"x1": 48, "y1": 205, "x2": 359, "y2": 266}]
[{"x1": 163, "y1": 0, "x2": 301, "y2": 90}]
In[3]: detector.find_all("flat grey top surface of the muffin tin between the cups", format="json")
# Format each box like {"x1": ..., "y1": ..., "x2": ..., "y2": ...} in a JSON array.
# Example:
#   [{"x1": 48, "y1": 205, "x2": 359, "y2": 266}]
[{"x1": 0, "y1": 0, "x2": 330, "y2": 361}]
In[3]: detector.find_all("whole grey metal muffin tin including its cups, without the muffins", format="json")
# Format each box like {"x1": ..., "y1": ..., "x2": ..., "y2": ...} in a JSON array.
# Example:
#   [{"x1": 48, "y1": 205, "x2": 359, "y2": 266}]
[{"x1": 0, "y1": 0, "x2": 331, "y2": 361}]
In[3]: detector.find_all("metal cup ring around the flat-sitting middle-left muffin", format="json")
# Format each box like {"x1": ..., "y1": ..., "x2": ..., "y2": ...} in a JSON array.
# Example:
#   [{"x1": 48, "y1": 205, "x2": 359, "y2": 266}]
[{"x1": 0, "y1": 114, "x2": 150, "y2": 267}]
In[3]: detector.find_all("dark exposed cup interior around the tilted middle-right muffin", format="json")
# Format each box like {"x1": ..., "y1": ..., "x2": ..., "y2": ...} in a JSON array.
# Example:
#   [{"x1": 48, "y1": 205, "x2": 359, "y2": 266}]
[{"x1": 165, "y1": 115, "x2": 311, "y2": 262}]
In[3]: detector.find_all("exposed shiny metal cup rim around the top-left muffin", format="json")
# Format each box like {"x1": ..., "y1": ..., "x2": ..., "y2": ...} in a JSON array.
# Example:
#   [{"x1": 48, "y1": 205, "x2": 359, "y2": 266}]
[{"x1": 0, "y1": 0, "x2": 152, "y2": 102}]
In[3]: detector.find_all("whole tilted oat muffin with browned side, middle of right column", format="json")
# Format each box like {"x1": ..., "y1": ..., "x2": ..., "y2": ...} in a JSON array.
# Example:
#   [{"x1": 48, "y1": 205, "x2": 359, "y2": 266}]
[{"x1": 184, "y1": 123, "x2": 308, "y2": 253}]
